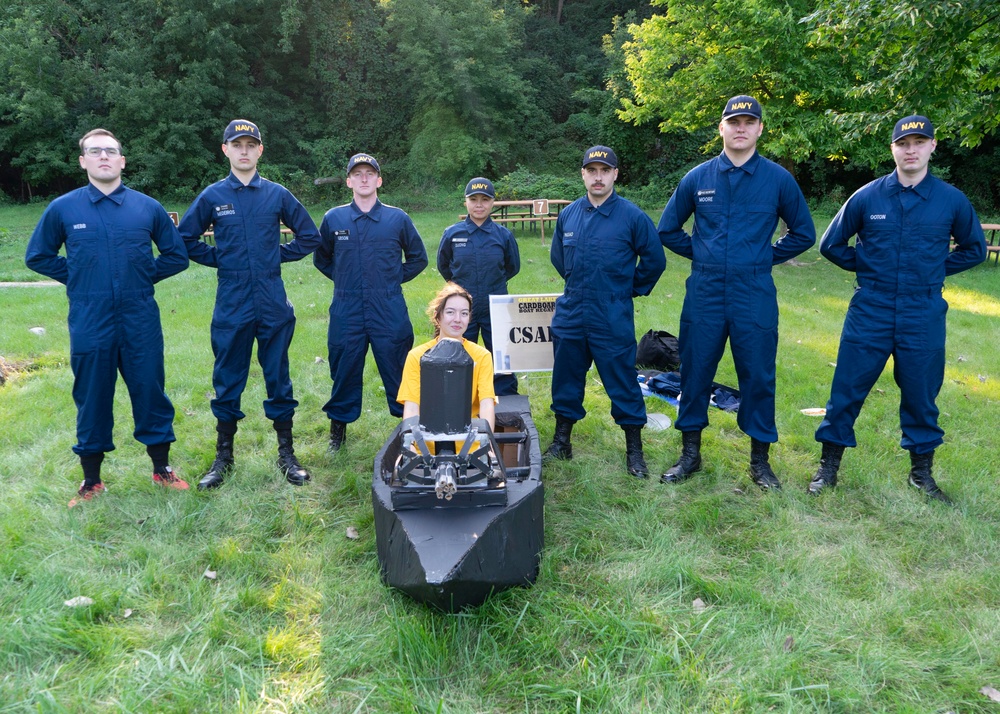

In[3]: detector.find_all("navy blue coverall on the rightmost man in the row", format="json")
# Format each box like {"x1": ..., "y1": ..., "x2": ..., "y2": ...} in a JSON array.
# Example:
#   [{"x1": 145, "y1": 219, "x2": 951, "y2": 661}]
[{"x1": 816, "y1": 171, "x2": 986, "y2": 454}]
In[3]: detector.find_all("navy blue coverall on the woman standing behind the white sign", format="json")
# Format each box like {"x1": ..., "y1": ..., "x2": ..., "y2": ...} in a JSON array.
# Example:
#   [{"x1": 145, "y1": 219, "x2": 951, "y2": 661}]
[{"x1": 438, "y1": 218, "x2": 521, "y2": 397}]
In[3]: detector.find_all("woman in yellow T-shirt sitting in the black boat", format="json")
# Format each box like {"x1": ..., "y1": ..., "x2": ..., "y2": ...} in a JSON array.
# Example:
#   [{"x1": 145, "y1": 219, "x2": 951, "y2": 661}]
[{"x1": 396, "y1": 282, "x2": 497, "y2": 429}]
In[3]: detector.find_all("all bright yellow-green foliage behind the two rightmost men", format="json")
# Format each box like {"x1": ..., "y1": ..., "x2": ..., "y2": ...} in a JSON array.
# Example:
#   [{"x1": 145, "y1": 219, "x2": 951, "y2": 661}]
[{"x1": 620, "y1": 0, "x2": 1000, "y2": 210}]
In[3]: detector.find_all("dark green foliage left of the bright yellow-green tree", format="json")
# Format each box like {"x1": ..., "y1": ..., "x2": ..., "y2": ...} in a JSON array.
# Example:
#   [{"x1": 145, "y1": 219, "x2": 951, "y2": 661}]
[{"x1": 0, "y1": 0, "x2": 642, "y2": 200}]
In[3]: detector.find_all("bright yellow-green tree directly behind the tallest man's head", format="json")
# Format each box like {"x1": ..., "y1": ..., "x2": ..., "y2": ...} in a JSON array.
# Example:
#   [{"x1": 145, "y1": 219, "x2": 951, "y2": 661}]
[{"x1": 620, "y1": 0, "x2": 844, "y2": 168}]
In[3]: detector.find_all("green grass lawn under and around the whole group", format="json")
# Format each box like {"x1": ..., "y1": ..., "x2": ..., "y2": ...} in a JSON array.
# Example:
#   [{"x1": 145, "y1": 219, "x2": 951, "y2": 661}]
[{"x1": 0, "y1": 197, "x2": 1000, "y2": 713}]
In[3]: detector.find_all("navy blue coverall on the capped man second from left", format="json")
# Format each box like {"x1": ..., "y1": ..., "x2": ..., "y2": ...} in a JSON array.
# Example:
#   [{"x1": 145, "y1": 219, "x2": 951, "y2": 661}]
[{"x1": 180, "y1": 173, "x2": 319, "y2": 423}]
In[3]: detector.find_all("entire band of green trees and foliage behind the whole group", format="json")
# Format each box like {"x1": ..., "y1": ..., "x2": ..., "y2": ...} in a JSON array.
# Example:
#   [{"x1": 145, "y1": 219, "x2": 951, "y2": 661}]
[{"x1": 0, "y1": 0, "x2": 1000, "y2": 212}]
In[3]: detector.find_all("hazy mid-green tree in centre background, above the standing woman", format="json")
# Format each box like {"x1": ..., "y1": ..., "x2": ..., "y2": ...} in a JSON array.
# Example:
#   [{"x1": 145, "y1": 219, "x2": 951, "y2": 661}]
[{"x1": 388, "y1": 0, "x2": 543, "y2": 184}]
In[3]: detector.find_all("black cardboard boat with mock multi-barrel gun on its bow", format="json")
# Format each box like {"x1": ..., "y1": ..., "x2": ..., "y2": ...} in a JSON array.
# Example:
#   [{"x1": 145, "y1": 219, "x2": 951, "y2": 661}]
[{"x1": 372, "y1": 392, "x2": 544, "y2": 612}]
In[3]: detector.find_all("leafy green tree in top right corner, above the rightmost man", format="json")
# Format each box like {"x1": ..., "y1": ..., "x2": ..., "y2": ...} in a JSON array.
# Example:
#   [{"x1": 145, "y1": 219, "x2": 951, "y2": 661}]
[{"x1": 803, "y1": 0, "x2": 1000, "y2": 165}]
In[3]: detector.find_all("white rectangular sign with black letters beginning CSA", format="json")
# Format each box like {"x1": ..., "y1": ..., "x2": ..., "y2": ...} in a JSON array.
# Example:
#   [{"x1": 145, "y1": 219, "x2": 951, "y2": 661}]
[{"x1": 490, "y1": 293, "x2": 561, "y2": 374}]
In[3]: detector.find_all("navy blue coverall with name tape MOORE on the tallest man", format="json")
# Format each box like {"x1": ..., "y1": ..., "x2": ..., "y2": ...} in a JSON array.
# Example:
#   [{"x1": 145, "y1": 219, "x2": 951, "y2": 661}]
[{"x1": 659, "y1": 152, "x2": 816, "y2": 443}]
